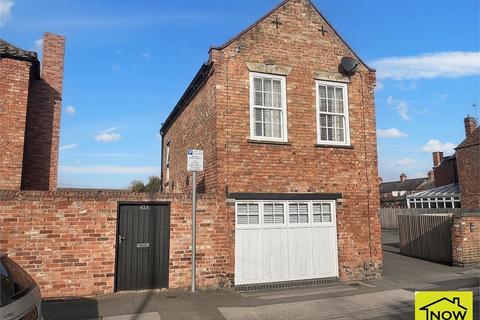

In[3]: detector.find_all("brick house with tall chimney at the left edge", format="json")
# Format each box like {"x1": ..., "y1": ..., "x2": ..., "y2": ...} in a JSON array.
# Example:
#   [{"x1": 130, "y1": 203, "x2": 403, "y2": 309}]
[{"x1": 0, "y1": 33, "x2": 65, "y2": 190}]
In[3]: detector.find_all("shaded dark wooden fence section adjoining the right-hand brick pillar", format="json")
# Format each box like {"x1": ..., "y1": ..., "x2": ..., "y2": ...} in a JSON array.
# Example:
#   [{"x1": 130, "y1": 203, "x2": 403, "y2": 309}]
[{"x1": 398, "y1": 214, "x2": 453, "y2": 264}]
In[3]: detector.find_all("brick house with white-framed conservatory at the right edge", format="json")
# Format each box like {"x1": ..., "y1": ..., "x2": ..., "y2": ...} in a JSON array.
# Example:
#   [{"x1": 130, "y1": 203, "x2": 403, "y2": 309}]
[{"x1": 407, "y1": 116, "x2": 480, "y2": 209}]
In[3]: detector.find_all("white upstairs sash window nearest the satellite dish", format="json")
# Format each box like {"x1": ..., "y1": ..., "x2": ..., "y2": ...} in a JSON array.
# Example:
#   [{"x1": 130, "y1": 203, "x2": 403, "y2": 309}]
[{"x1": 316, "y1": 81, "x2": 350, "y2": 145}]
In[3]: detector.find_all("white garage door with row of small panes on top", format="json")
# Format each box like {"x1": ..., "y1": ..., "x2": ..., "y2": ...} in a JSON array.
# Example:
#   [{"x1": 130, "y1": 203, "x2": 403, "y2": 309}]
[{"x1": 235, "y1": 201, "x2": 338, "y2": 285}]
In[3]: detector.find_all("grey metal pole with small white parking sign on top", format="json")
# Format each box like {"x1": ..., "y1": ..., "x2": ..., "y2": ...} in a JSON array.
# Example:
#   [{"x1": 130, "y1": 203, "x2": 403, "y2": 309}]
[{"x1": 187, "y1": 149, "x2": 203, "y2": 292}]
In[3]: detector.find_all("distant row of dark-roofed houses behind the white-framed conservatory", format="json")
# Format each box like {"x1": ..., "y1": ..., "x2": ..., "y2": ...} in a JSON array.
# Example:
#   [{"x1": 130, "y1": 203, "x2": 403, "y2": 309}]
[{"x1": 380, "y1": 171, "x2": 435, "y2": 208}]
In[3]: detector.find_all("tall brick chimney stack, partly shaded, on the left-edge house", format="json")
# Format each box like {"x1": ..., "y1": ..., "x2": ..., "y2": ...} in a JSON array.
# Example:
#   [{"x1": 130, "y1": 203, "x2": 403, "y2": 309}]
[{"x1": 22, "y1": 33, "x2": 65, "y2": 190}]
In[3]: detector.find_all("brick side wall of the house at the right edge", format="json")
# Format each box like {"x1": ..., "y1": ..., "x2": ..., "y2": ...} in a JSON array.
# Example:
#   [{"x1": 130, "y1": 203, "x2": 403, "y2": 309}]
[{"x1": 457, "y1": 129, "x2": 480, "y2": 209}]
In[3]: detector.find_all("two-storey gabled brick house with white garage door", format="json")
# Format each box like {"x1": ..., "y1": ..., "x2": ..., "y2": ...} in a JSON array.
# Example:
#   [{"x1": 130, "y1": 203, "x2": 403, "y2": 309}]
[{"x1": 160, "y1": 0, "x2": 382, "y2": 285}]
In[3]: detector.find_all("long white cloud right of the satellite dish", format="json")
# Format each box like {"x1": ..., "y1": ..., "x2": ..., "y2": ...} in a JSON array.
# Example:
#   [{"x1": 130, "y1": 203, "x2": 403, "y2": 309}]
[{"x1": 372, "y1": 51, "x2": 480, "y2": 80}]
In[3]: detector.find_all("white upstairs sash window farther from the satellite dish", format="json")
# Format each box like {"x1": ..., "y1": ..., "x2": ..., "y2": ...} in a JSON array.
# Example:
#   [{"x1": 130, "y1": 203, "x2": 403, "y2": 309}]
[{"x1": 250, "y1": 73, "x2": 287, "y2": 142}]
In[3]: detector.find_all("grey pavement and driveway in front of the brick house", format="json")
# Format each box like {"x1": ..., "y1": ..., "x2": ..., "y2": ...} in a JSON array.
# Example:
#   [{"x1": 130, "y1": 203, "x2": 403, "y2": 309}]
[{"x1": 43, "y1": 231, "x2": 480, "y2": 320}]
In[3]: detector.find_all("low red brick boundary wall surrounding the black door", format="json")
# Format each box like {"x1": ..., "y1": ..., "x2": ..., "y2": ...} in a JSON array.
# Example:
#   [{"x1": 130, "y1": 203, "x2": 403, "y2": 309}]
[{"x1": 0, "y1": 191, "x2": 233, "y2": 297}]
